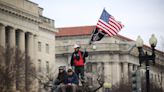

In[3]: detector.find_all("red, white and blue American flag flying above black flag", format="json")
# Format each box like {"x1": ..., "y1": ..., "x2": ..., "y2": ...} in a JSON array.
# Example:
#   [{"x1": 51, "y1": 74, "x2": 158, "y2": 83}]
[{"x1": 96, "y1": 9, "x2": 123, "y2": 36}]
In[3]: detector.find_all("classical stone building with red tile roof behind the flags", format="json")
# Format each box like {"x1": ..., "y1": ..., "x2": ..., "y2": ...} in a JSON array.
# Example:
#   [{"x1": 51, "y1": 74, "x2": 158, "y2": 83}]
[{"x1": 56, "y1": 26, "x2": 164, "y2": 91}]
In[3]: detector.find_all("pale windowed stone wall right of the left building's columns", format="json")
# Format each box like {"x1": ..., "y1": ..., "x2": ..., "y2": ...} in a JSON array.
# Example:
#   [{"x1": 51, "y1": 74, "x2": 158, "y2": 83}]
[{"x1": 36, "y1": 29, "x2": 55, "y2": 72}]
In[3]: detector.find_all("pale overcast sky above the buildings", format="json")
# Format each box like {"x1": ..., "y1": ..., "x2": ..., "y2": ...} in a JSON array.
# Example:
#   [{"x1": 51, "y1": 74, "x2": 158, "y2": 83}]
[{"x1": 31, "y1": 0, "x2": 164, "y2": 49}]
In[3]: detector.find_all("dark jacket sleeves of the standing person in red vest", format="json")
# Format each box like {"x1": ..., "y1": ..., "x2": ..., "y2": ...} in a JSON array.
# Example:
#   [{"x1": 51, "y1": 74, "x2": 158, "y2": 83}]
[{"x1": 71, "y1": 50, "x2": 88, "y2": 66}]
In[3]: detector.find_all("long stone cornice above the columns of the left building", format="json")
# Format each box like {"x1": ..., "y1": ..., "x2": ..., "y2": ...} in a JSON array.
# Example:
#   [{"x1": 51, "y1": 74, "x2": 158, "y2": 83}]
[{"x1": 0, "y1": 2, "x2": 41, "y2": 23}]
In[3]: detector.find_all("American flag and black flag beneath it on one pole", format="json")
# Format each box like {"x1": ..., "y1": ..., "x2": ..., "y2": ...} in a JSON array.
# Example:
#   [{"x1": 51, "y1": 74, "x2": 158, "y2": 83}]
[{"x1": 90, "y1": 9, "x2": 123, "y2": 44}]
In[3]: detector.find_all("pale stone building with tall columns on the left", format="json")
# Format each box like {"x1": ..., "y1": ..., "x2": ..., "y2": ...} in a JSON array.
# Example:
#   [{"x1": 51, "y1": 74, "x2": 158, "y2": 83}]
[{"x1": 0, "y1": 0, "x2": 56, "y2": 92}]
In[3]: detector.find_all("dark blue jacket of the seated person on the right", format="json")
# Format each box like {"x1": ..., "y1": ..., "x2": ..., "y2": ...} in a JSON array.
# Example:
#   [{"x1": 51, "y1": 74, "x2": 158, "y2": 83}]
[{"x1": 64, "y1": 73, "x2": 79, "y2": 85}]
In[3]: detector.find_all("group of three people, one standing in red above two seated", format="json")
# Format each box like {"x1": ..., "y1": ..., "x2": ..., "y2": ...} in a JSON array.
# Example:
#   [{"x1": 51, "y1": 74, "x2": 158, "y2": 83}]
[{"x1": 54, "y1": 44, "x2": 88, "y2": 92}]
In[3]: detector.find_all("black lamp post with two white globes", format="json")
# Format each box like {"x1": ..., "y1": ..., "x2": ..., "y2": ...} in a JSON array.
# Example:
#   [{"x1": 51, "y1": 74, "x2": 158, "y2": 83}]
[{"x1": 136, "y1": 34, "x2": 157, "y2": 92}]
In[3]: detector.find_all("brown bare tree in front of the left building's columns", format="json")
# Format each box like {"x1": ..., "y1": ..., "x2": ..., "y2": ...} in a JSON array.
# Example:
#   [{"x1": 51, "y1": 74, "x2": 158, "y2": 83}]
[{"x1": 0, "y1": 46, "x2": 35, "y2": 92}]
